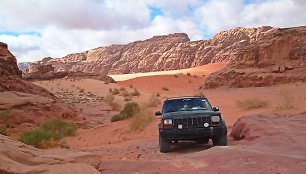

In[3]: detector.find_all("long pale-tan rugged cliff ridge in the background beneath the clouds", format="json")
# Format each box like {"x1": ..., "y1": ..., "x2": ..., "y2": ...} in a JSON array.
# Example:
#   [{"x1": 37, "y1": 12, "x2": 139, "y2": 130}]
[{"x1": 25, "y1": 27, "x2": 275, "y2": 76}]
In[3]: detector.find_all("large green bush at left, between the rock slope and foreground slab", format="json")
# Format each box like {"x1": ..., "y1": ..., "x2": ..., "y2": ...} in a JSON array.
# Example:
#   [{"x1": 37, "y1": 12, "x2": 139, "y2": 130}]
[{"x1": 19, "y1": 119, "x2": 77, "y2": 149}]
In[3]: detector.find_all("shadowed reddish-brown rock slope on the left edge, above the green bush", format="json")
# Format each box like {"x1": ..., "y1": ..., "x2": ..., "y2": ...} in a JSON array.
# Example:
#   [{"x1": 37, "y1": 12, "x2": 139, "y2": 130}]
[{"x1": 0, "y1": 43, "x2": 77, "y2": 127}]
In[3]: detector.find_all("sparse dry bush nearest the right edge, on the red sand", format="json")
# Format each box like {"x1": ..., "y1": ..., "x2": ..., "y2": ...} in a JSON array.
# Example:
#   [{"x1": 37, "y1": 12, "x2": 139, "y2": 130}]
[{"x1": 278, "y1": 89, "x2": 295, "y2": 109}]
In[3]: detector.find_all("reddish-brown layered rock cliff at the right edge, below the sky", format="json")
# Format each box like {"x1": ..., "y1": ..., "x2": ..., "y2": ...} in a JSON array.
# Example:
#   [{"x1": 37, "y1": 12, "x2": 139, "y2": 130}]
[{"x1": 204, "y1": 27, "x2": 306, "y2": 88}]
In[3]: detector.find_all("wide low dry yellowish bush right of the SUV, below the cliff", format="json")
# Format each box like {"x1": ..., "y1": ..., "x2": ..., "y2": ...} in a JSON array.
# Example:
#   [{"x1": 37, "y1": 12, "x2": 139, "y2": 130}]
[{"x1": 236, "y1": 97, "x2": 270, "y2": 110}]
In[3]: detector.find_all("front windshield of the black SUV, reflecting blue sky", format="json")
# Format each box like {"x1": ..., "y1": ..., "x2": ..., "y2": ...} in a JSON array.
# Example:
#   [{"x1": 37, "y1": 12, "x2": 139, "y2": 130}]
[{"x1": 162, "y1": 98, "x2": 211, "y2": 113}]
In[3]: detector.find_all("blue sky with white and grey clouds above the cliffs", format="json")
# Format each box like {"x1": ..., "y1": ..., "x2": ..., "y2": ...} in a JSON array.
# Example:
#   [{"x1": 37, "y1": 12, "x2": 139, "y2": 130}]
[{"x1": 0, "y1": 0, "x2": 306, "y2": 62}]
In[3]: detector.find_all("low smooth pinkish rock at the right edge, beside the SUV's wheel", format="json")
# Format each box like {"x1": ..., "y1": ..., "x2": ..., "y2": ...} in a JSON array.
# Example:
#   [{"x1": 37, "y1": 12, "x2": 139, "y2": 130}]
[{"x1": 231, "y1": 113, "x2": 306, "y2": 158}]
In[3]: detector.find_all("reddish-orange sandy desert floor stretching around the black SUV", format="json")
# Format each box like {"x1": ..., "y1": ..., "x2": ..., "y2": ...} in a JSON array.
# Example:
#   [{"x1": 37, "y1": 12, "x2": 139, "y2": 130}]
[{"x1": 30, "y1": 63, "x2": 306, "y2": 173}]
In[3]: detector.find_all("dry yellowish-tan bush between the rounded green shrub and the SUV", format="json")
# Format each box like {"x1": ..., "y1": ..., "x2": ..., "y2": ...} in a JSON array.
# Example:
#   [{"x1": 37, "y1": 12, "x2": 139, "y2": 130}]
[{"x1": 129, "y1": 107, "x2": 153, "y2": 131}]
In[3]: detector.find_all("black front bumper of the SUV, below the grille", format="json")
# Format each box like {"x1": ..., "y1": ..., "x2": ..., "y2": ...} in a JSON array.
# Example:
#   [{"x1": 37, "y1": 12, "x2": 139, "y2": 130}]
[{"x1": 159, "y1": 125, "x2": 227, "y2": 141}]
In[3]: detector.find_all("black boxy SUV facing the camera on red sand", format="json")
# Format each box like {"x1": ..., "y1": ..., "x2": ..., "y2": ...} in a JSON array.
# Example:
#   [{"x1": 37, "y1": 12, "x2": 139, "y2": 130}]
[{"x1": 155, "y1": 97, "x2": 227, "y2": 153}]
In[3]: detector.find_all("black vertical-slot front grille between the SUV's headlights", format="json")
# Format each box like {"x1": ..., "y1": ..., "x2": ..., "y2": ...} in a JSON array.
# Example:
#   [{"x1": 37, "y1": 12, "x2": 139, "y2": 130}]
[{"x1": 173, "y1": 116, "x2": 211, "y2": 128}]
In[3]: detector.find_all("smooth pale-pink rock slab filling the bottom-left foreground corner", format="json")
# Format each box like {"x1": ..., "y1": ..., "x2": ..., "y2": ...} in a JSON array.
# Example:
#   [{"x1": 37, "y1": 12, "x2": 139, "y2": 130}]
[{"x1": 0, "y1": 134, "x2": 101, "y2": 174}]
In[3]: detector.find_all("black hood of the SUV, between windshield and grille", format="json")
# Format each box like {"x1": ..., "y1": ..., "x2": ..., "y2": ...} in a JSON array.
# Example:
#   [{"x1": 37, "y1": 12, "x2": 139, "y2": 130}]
[{"x1": 162, "y1": 110, "x2": 221, "y2": 118}]
